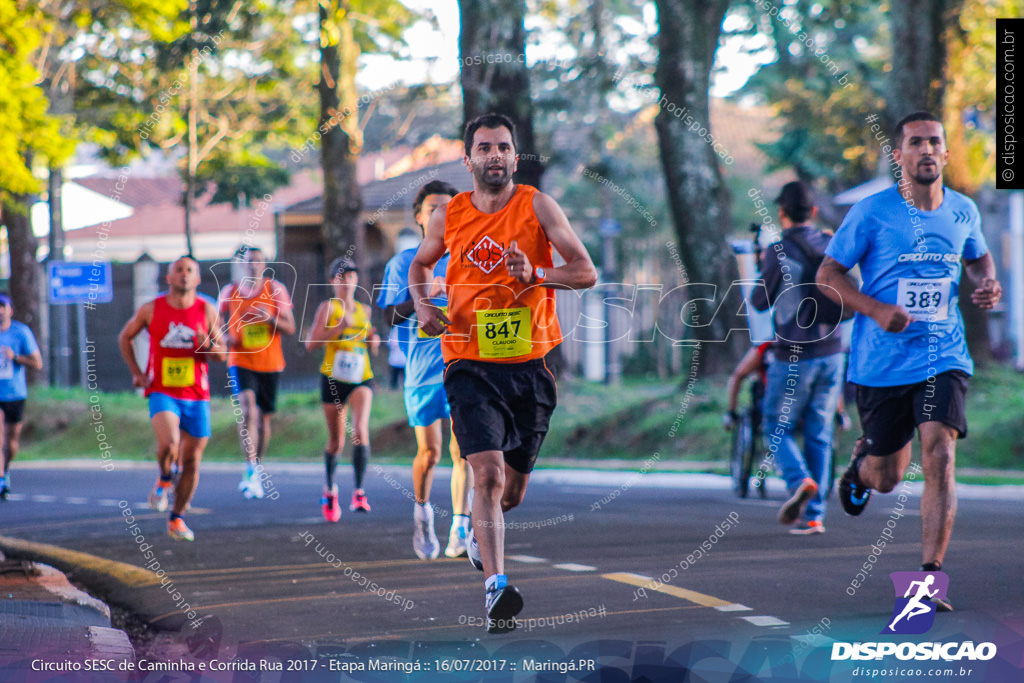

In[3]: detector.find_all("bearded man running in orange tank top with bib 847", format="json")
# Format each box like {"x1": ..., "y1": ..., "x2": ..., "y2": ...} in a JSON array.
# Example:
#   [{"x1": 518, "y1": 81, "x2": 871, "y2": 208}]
[{"x1": 409, "y1": 114, "x2": 597, "y2": 633}]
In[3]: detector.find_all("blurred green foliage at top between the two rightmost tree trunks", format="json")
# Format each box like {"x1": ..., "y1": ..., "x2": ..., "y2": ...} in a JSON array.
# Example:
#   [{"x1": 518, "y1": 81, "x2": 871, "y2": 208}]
[{"x1": 731, "y1": 0, "x2": 891, "y2": 189}]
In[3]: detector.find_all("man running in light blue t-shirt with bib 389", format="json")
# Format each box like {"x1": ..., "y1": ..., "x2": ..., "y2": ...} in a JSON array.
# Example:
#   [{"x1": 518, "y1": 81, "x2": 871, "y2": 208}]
[{"x1": 817, "y1": 112, "x2": 1001, "y2": 610}]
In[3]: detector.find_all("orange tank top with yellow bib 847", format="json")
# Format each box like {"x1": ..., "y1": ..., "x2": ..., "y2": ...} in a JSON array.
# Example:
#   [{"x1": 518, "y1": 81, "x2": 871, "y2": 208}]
[{"x1": 441, "y1": 185, "x2": 562, "y2": 362}]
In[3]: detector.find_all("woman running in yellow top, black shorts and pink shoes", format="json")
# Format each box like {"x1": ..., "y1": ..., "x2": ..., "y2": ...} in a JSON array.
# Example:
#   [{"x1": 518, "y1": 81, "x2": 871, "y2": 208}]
[{"x1": 305, "y1": 257, "x2": 381, "y2": 522}]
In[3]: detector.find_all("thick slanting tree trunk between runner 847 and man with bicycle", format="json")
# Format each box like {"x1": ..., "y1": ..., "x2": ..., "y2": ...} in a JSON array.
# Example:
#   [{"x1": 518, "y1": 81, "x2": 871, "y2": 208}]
[{"x1": 654, "y1": 0, "x2": 742, "y2": 371}]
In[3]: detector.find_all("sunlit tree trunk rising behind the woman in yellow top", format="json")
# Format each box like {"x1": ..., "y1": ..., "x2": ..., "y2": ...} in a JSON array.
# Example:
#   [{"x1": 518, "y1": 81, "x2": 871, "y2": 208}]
[{"x1": 316, "y1": 2, "x2": 365, "y2": 266}]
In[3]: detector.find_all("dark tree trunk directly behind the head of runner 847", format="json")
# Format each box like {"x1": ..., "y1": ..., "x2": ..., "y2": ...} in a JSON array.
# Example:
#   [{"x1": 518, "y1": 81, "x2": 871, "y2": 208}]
[{"x1": 459, "y1": 0, "x2": 544, "y2": 188}]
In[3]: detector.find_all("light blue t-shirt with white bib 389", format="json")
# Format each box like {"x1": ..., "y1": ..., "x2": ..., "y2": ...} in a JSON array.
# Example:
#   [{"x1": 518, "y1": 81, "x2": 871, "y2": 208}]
[{"x1": 825, "y1": 184, "x2": 988, "y2": 387}]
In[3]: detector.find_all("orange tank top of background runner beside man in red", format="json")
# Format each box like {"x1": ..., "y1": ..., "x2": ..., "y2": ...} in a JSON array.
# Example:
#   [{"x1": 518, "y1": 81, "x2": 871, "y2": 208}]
[{"x1": 225, "y1": 280, "x2": 285, "y2": 373}]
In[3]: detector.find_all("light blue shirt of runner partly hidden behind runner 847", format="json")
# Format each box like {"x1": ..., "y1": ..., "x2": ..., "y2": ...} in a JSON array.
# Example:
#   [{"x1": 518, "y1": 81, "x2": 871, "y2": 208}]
[{"x1": 377, "y1": 247, "x2": 449, "y2": 387}]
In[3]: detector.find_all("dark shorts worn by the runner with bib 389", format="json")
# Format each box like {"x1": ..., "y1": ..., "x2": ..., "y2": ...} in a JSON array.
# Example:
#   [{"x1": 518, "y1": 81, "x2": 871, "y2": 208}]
[{"x1": 857, "y1": 370, "x2": 968, "y2": 456}]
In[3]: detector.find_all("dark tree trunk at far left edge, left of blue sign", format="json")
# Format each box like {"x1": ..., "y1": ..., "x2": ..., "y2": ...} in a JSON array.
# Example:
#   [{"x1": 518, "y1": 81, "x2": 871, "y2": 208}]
[{"x1": 3, "y1": 193, "x2": 45, "y2": 384}]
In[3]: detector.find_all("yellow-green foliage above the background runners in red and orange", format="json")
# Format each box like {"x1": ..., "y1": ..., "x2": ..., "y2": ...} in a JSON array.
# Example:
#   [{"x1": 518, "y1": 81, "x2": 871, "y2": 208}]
[{"x1": 76, "y1": 0, "x2": 315, "y2": 192}]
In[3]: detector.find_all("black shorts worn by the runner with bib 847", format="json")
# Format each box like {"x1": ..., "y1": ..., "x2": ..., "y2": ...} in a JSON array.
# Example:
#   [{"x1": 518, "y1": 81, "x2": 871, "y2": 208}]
[{"x1": 444, "y1": 358, "x2": 558, "y2": 474}]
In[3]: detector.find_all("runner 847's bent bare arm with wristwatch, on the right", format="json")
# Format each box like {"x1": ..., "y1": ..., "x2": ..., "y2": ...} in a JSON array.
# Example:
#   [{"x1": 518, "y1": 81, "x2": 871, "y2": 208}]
[{"x1": 505, "y1": 193, "x2": 597, "y2": 290}]
